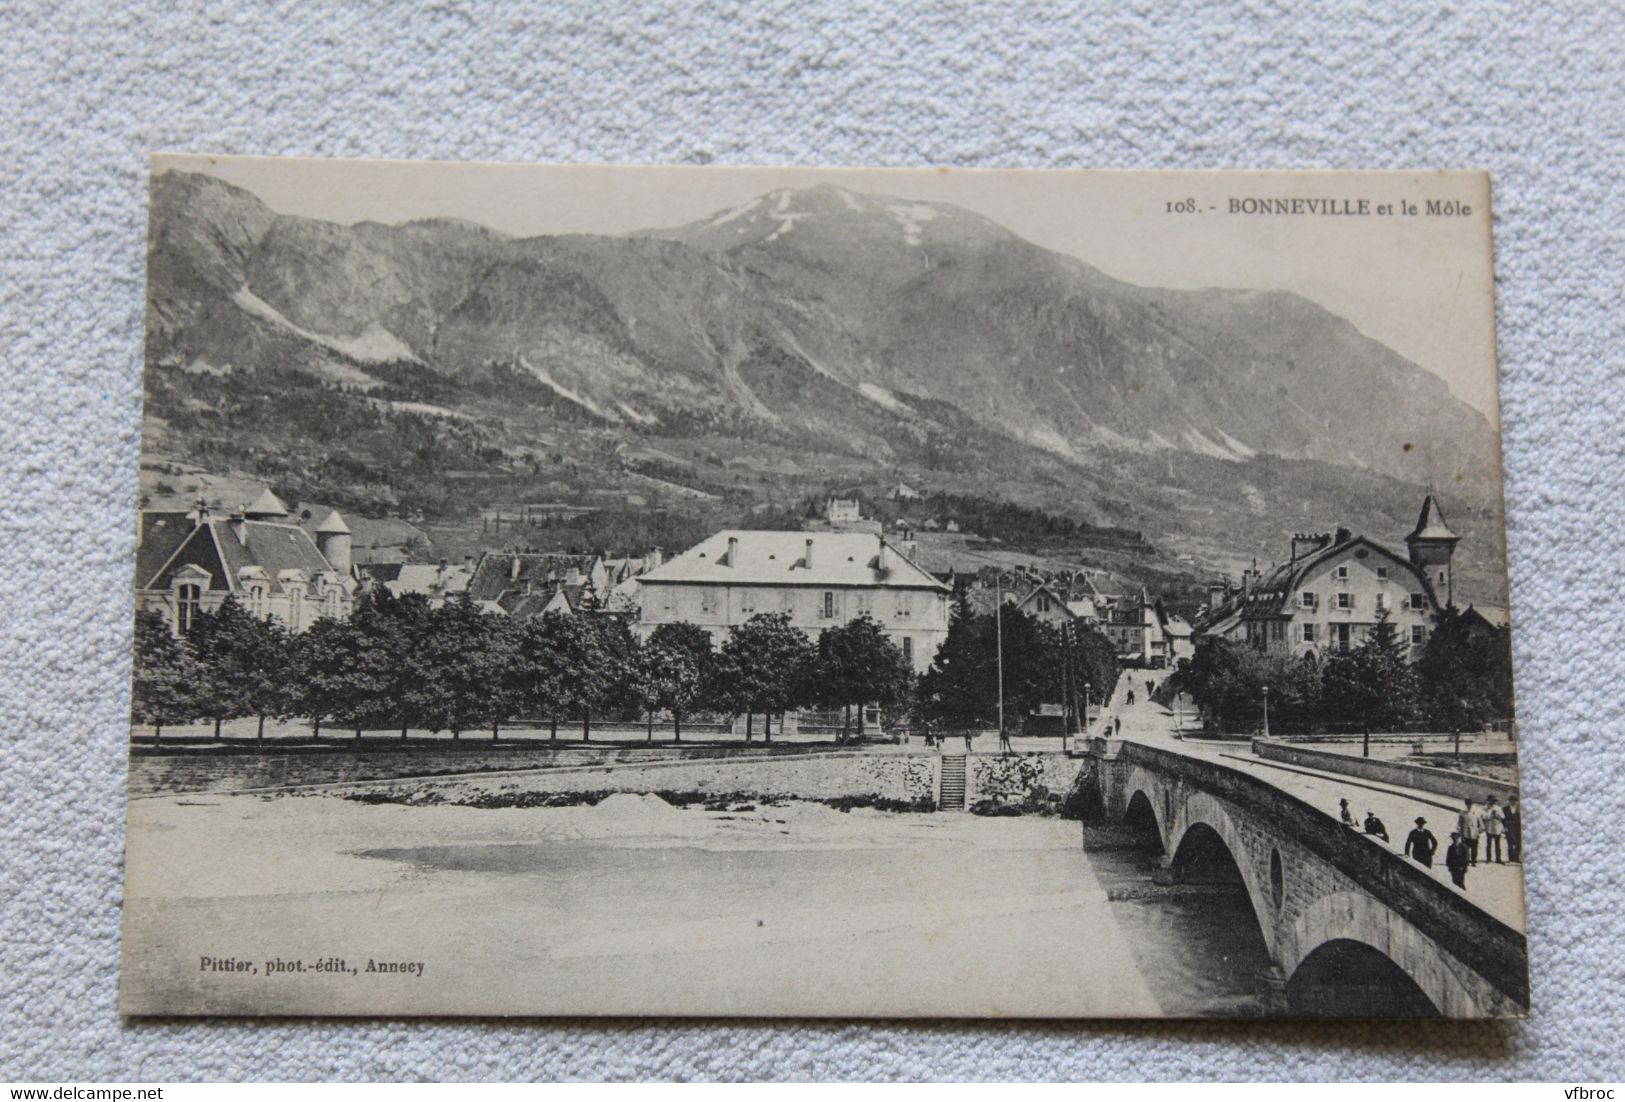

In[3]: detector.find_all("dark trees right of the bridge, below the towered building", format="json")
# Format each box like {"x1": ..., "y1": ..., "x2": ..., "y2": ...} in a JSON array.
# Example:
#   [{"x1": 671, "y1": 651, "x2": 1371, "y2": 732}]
[{"x1": 1164, "y1": 608, "x2": 1513, "y2": 733}]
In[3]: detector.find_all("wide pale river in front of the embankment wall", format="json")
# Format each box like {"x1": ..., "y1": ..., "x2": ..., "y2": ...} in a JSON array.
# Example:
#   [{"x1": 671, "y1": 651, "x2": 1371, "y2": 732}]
[{"x1": 122, "y1": 796, "x2": 1263, "y2": 1017}]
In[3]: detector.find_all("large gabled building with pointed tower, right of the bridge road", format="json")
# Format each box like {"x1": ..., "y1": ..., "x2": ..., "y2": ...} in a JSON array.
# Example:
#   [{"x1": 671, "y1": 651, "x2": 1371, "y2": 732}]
[{"x1": 1198, "y1": 492, "x2": 1459, "y2": 660}]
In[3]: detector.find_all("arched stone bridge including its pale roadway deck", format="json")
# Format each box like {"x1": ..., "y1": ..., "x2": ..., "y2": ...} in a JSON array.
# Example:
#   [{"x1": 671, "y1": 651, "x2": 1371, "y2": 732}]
[{"x1": 1079, "y1": 671, "x2": 1529, "y2": 1016}]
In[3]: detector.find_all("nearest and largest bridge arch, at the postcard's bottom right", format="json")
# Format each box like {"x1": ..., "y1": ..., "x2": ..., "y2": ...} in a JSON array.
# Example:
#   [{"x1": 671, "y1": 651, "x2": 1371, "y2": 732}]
[{"x1": 1276, "y1": 892, "x2": 1500, "y2": 1017}]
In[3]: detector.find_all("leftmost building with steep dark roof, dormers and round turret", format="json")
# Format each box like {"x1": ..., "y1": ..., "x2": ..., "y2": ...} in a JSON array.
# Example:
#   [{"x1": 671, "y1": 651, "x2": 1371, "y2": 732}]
[{"x1": 135, "y1": 489, "x2": 356, "y2": 634}]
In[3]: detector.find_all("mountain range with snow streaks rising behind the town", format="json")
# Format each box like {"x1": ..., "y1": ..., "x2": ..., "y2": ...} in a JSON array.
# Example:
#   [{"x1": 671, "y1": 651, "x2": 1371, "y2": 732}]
[{"x1": 146, "y1": 172, "x2": 1500, "y2": 594}]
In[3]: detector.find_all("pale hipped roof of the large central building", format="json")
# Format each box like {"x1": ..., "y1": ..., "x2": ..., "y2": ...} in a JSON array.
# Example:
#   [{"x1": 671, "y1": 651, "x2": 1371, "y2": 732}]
[{"x1": 639, "y1": 530, "x2": 947, "y2": 593}]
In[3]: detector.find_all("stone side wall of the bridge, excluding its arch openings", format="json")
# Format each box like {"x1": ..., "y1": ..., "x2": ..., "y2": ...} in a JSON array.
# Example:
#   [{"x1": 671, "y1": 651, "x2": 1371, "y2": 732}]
[{"x1": 1090, "y1": 740, "x2": 1529, "y2": 1014}]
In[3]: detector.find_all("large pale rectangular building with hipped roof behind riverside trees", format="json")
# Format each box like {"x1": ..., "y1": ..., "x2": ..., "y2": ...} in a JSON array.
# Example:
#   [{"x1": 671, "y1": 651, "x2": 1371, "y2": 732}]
[{"x1": 635, "y1": 530, "x2": 951, "y2": 673}]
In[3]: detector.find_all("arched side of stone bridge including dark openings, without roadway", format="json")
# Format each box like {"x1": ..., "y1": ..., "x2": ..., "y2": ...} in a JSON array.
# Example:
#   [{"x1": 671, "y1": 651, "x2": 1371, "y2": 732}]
[{"x1": 1081, "y1": 738, "x2": 1529, "y2": 1017}]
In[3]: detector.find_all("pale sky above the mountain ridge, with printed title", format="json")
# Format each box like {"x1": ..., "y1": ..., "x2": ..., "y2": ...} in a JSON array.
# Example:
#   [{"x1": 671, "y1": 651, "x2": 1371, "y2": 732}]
[{"x1": 153, "y1": 154, "x2": 1500, "y2": 426}]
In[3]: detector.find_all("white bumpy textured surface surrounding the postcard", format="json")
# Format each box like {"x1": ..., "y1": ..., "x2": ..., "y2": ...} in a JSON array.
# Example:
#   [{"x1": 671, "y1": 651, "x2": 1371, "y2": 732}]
[{"x1": 0, "y1": 0, "x2": 1625, "y2": 1081}]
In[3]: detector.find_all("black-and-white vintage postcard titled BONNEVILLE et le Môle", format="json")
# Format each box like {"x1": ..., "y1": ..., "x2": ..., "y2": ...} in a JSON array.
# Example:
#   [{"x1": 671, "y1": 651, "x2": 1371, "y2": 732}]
[{"x1": 120, "y1": 154, "x2": 1529, "y2": 1017}]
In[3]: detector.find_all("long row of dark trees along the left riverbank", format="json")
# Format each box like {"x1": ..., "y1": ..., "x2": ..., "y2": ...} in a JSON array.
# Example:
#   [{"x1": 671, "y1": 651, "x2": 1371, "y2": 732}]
[{"x1": 133, "y1": 592, "x2": 915, "y2": 740}]
